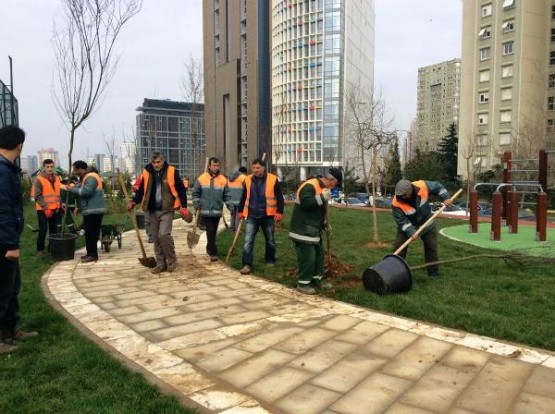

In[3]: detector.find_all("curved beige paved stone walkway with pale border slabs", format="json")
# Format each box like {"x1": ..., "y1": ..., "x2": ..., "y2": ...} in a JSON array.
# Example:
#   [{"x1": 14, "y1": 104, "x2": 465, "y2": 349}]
[{"x1": 43, "y1": 221, "x2": 555, "y2": 414}]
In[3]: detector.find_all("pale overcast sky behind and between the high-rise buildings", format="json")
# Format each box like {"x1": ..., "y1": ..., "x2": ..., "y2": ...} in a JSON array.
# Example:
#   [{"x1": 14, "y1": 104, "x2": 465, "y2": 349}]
[{"x1": 0, "y1": 0, "x2": 462, "y2": 166}]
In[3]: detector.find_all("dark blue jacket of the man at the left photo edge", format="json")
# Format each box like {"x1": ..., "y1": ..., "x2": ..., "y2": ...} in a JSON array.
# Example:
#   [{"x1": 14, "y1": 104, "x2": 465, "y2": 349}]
[{"x1": 0, "y1": 155, "x2": 24, "y2": 250}]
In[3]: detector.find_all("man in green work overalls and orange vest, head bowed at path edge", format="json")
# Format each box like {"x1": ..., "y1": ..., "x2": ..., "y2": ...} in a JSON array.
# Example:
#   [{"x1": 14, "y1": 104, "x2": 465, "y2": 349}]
[{"x1": 289, "y1": 168, "x2": 343, "y2": 295}]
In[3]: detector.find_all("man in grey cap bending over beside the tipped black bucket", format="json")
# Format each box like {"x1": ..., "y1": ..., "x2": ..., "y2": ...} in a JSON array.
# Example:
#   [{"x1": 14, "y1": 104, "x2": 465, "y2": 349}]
[{"x1": 391, "y1": 180, "x2": 453, "y2": 279}]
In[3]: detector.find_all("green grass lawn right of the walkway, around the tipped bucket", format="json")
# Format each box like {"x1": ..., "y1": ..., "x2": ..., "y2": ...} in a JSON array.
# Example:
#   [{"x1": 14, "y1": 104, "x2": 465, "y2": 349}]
[{"x1": 218, "y1": 206, "x2": 555, "y2": 351}]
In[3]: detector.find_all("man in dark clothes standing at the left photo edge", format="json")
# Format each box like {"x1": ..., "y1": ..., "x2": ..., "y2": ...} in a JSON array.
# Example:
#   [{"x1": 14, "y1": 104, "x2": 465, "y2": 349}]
[{"x1": 0, "y1": 126, "x2": 38, "y2": 354}]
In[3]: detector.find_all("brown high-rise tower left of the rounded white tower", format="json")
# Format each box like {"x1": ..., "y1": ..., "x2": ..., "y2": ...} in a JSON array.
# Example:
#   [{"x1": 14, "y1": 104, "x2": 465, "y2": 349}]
[{"x1": 203, "y1": 0, "x2": 271, "y2": 171}]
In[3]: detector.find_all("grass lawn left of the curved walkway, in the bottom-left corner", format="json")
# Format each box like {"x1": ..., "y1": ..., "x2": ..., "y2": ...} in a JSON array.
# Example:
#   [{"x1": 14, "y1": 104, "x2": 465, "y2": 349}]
[{"x1": 0, "y1": 204, "x2": 195, "y2": 414}]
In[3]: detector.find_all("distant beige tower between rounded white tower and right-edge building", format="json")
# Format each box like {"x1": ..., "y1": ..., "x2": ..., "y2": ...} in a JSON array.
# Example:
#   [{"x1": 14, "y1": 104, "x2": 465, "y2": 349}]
[{"x1": 412, "y1": 59, "x2": 461, "y2": 152}]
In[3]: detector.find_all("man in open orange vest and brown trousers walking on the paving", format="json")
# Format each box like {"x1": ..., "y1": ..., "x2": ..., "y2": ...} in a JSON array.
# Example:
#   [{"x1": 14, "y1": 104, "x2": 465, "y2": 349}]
[{"x1": 127, "y1": 151, "x2": 189, "y2": 274}]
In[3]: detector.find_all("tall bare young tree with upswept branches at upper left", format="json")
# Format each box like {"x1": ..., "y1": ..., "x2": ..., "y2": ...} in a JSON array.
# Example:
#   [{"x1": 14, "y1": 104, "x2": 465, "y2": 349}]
[{"x1": 53, "y1": 0, "x2": 142, "y2": 168}]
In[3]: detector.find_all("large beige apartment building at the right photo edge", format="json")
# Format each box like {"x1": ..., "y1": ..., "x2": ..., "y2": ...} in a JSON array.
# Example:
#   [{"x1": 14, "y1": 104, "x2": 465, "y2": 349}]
[{"x1": 458, "y1": 0, "x2": 555, "y2": 177}]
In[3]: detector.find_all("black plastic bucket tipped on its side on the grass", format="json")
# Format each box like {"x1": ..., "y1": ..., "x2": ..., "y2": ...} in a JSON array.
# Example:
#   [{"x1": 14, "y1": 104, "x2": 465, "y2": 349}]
[{"x1": 362, "y1": 254, "x2": 412, "y2": 295}]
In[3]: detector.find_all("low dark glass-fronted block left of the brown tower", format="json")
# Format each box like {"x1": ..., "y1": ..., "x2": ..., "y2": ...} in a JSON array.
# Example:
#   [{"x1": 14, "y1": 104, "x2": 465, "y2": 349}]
[{"x1": 136, "y1": 99, "x2": 205, "y2": 179}]
